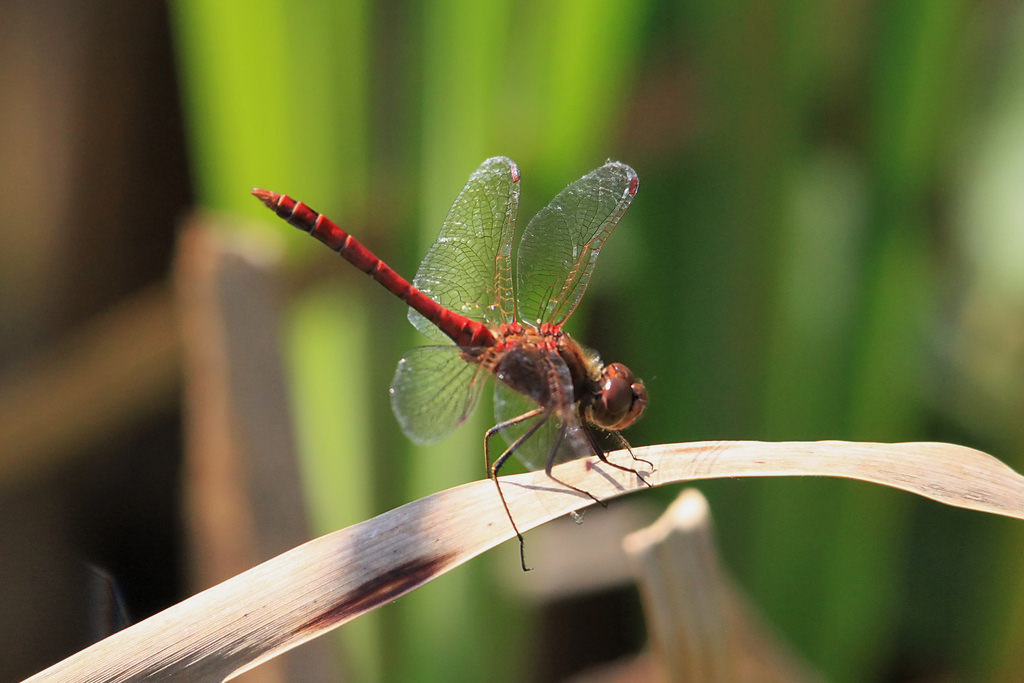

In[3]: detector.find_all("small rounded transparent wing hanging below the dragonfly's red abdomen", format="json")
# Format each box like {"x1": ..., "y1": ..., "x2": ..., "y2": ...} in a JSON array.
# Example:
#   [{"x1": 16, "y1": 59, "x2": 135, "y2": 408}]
[{"x1": 391, "y1": 344, "x2": 487, "y2": 445}]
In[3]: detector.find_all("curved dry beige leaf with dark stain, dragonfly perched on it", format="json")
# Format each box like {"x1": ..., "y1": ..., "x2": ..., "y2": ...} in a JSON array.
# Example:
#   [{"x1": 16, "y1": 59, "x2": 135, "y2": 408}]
[{"x1": 30, "y1": 441, "x2": 1024, "y2": 681}]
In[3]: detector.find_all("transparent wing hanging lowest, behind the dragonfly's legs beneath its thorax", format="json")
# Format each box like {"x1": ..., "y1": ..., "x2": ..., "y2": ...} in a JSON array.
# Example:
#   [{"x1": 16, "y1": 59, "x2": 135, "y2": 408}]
[{"x1": 492, "y1": 366, "x2": 593, "y2": 470}]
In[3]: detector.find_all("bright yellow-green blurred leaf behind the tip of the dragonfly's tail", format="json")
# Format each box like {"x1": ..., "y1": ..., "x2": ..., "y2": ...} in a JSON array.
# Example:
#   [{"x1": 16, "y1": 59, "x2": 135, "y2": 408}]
[{"x1": 169, "y1": 0, "x2": 382, "y2": 678}]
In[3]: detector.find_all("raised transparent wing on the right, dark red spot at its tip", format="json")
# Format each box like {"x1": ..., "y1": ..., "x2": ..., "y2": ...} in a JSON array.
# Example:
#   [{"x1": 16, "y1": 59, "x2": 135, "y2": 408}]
[{"x1": 516, "y1": 161, "x2": 639, "y2": 327}]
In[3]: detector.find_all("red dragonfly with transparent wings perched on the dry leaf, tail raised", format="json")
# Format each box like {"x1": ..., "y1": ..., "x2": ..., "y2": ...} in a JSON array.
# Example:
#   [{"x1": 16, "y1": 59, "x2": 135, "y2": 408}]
[{"x1": 260, "y1": 157, "x2": 649, "y2": 570}]
